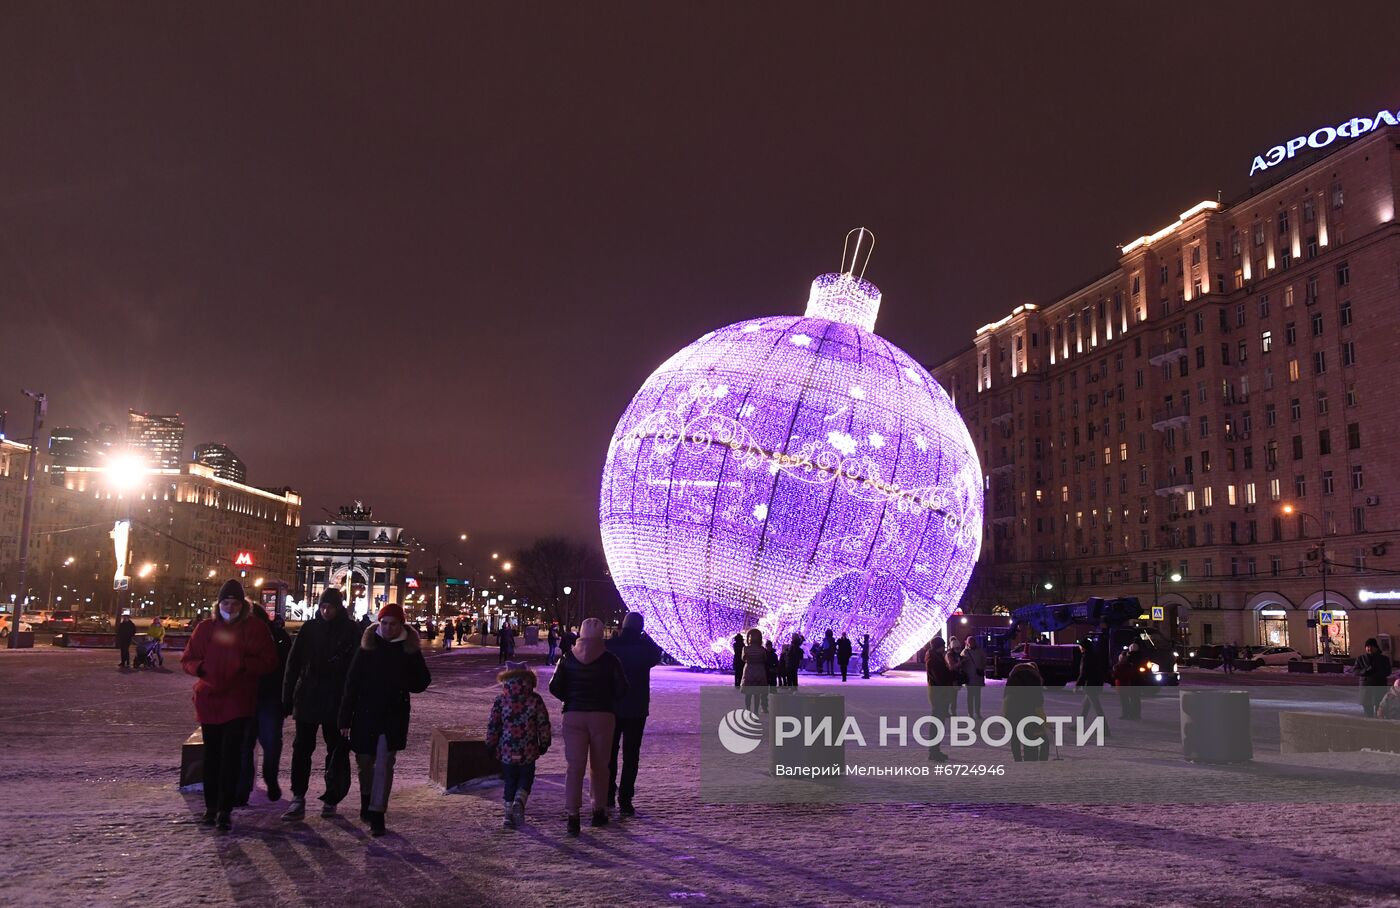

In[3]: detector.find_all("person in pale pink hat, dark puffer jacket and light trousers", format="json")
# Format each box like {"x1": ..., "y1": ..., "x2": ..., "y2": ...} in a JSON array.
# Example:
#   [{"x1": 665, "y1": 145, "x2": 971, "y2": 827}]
[{"x1": 549, "y1": 618, "x2": 627, "y2": 835}]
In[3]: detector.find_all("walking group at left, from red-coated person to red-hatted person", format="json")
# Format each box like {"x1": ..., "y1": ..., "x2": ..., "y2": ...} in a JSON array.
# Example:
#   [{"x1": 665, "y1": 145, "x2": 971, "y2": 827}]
[{"x1": 181, "y1": 581, "x2": 431, "y2": 835}]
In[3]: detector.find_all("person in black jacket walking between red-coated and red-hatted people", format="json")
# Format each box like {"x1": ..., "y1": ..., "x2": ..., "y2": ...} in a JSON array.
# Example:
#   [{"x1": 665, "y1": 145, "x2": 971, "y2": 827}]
[{"x1": 281, "y1": 588, "x2": 370, "y2": 821}]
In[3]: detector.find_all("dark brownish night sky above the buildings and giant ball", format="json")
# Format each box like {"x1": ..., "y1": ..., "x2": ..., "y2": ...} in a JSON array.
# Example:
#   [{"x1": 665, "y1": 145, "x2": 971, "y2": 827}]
[{"x1": 0, "y1": 0, "x2": 1400, "y2": 554}]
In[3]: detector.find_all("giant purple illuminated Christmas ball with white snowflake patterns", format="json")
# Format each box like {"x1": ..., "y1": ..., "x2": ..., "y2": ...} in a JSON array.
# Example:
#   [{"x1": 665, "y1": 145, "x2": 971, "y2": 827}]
[{"x1": 599, "y1": 251, "x2": 983, "y2": 670}]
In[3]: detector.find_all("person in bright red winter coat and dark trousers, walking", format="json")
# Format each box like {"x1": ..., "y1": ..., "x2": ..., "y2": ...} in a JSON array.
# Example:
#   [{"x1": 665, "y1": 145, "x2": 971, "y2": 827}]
[{"x1": 181, "y1": 581, "x2": 279, "y2": 831}]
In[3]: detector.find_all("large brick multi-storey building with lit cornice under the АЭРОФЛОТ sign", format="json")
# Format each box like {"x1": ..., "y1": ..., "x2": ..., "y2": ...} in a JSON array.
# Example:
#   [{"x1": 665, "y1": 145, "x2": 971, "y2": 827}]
[{"x1": 931, "y1": 127, "x2": 1400, "y2": 655}]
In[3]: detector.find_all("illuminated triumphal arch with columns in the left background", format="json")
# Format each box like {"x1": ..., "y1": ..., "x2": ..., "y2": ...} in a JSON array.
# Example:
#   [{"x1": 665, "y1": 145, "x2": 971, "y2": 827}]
[{"x1": 297, "y1": 501, "x2": 409, "y2": 617}]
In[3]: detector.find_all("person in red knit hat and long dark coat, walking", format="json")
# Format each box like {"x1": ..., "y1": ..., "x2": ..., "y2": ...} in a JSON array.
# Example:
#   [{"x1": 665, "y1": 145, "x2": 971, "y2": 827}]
[{"x1": 339, "y1": 602, "x2": 433, "y2": 837}]
